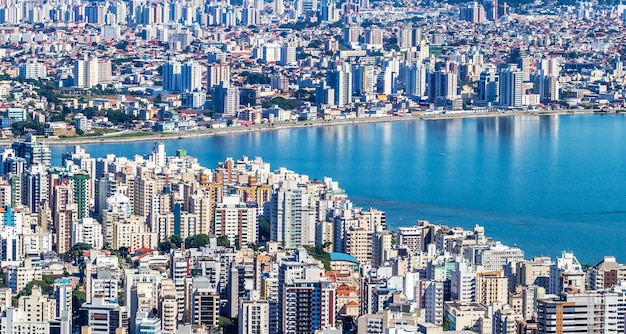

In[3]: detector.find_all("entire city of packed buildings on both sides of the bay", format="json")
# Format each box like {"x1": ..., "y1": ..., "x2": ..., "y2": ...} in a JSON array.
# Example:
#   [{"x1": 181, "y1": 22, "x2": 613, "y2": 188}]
[{"x1": 0, "y1": 0, "x2": 626, "y2": 334}]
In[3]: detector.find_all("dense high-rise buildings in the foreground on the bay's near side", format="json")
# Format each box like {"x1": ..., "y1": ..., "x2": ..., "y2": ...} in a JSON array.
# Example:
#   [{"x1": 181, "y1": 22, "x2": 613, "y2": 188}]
[{"x1": 0, "y1": 140, "x2": 626, "y2": 334}]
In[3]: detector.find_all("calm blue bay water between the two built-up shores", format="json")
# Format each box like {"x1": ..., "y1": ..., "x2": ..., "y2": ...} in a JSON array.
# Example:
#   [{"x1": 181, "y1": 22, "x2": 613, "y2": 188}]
[{"x1": 52, "y1": 115, "x2": 626, "y2": 264}]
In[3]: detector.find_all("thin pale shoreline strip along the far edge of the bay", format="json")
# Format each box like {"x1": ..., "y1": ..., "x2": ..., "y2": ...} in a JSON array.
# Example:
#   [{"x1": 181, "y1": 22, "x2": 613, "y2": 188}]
[{"x1": 0, "y1": 110, "x2": 596, "y2": 146}]
